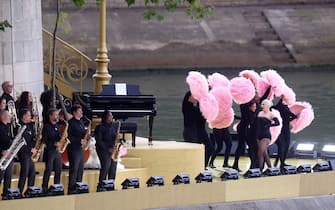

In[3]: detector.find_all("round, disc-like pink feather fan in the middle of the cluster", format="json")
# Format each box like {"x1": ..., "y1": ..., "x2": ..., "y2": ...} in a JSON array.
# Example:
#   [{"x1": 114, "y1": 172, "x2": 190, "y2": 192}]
[{"x1": 230, "y1": 77, "x2": 255, "y2": 104}]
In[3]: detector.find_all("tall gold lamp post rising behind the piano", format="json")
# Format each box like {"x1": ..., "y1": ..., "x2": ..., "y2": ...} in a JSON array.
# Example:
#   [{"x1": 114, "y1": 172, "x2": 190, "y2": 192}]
[{"x1": 93, "y1": 0, "x2": 112, "y2": 94}]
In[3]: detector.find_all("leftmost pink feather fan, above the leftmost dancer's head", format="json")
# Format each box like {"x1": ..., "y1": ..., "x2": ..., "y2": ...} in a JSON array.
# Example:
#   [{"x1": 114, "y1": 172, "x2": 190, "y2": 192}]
[{"x1": 186, "y1": 71, "x2": 209, "y2": 101}]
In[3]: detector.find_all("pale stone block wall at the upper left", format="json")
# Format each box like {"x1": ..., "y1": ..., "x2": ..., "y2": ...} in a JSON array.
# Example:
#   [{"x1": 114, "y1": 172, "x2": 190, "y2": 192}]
[{"x1": 0, "y1": 0, "x2": 44, "y2": 96}]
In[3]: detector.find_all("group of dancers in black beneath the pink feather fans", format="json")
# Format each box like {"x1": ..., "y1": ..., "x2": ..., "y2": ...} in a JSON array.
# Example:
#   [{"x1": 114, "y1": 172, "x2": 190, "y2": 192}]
[{"x1": 182, "y1": 87, "x2": 297, "y2": 171}]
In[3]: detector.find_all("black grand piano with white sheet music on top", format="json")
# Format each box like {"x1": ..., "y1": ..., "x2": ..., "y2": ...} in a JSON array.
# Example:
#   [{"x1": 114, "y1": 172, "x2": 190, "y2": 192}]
[{"x1": 73, "y1": 84, "x2": 157, "y2": 147}]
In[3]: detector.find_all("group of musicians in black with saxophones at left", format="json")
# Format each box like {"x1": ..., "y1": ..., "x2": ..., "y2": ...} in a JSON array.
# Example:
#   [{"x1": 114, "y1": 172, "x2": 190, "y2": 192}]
[{"x1": 0, "y1": 81, "x2": 117, "y2": 199}]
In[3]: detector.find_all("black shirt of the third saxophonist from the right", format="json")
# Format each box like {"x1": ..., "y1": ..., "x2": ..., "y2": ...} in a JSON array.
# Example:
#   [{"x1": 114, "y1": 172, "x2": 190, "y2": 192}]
[{"x1": 42, "y1": 123, "x2": 61, "y2": 151}]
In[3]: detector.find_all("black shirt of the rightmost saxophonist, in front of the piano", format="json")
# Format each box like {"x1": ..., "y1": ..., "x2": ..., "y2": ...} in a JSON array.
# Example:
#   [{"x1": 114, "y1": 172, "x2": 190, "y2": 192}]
[{"x1": 94, "y1": 123, "x2": 116, "y2": 151}]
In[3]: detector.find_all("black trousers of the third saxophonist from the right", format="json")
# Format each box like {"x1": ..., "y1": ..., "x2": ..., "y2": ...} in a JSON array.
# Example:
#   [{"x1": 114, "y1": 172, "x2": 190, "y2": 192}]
[{"x1": 42, "y1": 150, "x2": 62, "y2": 191}]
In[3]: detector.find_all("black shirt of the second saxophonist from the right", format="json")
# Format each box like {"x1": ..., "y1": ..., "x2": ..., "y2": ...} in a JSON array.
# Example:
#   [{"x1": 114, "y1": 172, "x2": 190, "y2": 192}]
[{"x1": 68, "y1": 118, "x2": 86, "y2": 149}]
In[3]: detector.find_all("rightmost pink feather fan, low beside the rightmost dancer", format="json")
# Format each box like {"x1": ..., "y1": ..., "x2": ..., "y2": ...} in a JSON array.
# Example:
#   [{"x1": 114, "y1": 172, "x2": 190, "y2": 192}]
[{"x1": 289, "y1": 102, "x2": 314, "y2": 133}]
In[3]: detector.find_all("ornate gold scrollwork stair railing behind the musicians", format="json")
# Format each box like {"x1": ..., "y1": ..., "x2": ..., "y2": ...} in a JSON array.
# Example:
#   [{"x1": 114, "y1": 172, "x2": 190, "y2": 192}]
[{"x1": 42, "y1": 29, "x2": 92, "y2": 98}]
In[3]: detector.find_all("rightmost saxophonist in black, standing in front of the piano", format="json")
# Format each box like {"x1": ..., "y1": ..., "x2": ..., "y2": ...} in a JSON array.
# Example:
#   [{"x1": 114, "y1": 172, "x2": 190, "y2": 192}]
[{"x1": 95, "y1": 110, "x2": 117, "y2": 192}]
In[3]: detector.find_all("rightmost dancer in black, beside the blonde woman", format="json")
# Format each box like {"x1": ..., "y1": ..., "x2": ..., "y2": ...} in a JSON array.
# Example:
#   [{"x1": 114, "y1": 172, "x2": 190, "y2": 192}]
[{"x1": 273, "y1": 95, "x2": 297, "y2": 169}]
